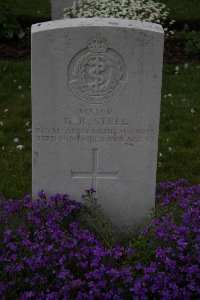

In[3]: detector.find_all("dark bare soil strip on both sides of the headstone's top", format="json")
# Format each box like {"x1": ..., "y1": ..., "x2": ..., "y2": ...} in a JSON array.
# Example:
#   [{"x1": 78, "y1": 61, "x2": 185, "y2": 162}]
[{"x1": 0, "y1": 28, "x2": 200, "y2": 64}]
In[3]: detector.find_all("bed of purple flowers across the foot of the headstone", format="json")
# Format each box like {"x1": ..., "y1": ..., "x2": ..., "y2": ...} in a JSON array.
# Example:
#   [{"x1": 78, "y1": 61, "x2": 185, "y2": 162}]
[{"x1": 0, "y1": 180, "x2": 200, "y2": 300}]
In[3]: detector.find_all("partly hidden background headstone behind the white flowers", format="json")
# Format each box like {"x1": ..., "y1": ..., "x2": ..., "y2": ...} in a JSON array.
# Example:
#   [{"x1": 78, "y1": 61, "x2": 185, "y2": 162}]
[{"x1": 51, "y1": 0, "x2": 74, "y2": 20}]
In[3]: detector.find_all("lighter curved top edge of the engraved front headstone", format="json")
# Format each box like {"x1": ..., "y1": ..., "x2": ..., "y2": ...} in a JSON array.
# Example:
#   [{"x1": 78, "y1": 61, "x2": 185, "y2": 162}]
[{"x1": 31, "y1": 18, "x2": 164, "y2": 34}]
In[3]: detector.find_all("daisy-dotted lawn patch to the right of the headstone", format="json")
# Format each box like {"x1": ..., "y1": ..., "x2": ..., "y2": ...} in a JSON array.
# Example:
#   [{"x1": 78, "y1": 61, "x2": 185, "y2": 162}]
[{"x1": 157, "y1": 65, "x2": 200, "y2": 183}]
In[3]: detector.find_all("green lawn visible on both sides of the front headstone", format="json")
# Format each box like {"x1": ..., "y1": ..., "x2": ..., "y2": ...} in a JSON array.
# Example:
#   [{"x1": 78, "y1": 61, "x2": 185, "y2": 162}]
[{"x1": 0, "y1": 61, "x2": 200, "y2": 198}]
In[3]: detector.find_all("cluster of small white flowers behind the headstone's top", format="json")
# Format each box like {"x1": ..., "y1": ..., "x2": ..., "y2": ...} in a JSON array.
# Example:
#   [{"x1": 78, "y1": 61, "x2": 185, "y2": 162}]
[{"x1": 64, "y1": 0, "x2": 172, "y2": 28}]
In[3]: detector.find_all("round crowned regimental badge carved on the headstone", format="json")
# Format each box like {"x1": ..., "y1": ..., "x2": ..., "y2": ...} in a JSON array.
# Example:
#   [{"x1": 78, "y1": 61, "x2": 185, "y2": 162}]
[{"x1": 68, "y1": 33, "x2": 127, "y2": 104}]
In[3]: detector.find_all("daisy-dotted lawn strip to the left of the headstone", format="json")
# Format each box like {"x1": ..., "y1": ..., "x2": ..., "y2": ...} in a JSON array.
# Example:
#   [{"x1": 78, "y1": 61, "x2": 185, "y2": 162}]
[{"x1": 0, "y1": 61, "x2": 31, "y2": 197}]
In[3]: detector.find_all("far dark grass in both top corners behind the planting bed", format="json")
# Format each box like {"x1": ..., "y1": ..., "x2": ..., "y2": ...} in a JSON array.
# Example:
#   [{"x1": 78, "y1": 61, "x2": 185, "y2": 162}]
[{"x1": 0, "y1": 0, "x2": 200, "y2": 27}]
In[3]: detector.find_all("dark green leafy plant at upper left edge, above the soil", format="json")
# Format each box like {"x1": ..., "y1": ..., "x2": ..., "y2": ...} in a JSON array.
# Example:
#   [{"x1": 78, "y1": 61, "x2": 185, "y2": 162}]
[{"x1": 0, "y1": 6, "x2": 24, "y2": 39}]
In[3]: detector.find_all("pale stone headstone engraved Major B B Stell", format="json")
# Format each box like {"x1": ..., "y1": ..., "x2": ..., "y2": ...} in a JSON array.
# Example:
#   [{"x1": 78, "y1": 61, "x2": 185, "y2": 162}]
[{"x1": 32, "y1": 18, "x2": 164, "y2": 232}]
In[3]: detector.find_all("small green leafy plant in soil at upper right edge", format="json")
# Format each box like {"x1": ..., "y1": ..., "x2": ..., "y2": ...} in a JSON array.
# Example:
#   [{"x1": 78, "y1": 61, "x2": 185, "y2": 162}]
[{"x1": 177, "y1": 25, "x2": 200, "y2": 55}]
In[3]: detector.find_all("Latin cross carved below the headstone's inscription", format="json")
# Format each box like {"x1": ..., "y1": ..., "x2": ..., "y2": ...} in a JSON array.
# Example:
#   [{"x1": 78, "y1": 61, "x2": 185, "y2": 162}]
[{"x1": 71, "y1": 149, "x2": 119, "y2": 191}]
